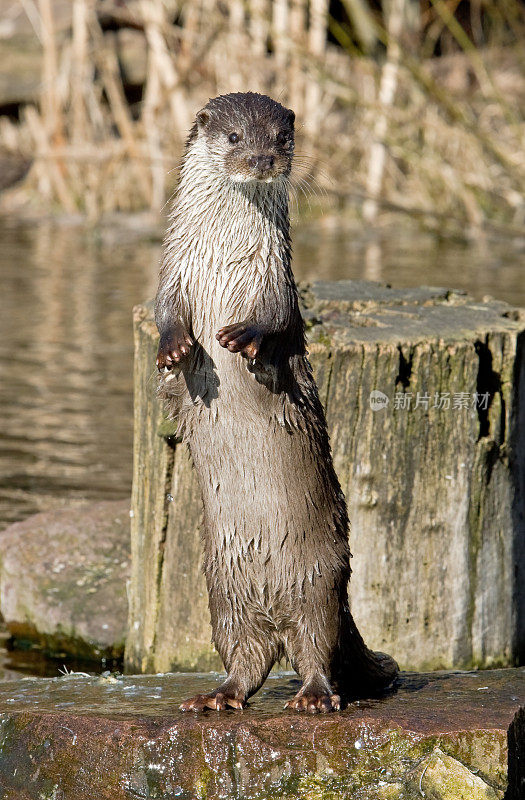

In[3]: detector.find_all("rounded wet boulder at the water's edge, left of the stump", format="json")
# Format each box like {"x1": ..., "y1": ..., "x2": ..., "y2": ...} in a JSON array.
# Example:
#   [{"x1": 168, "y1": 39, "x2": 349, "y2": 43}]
[{"x1": 0, "y1": 500, "x2": 130, "y2": 659}]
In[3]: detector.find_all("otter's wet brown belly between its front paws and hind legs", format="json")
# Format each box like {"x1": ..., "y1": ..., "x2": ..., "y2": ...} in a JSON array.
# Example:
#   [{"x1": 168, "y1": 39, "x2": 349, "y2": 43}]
[{"x1": 182, "y1": 348, "x2": 349, "y2": 599}]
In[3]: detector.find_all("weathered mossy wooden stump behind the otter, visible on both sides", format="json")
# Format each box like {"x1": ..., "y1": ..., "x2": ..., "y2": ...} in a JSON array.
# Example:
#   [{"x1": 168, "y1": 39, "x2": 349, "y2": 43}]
[{"x1": 126, "y1": 281, "x2": 525, "y2": 671}]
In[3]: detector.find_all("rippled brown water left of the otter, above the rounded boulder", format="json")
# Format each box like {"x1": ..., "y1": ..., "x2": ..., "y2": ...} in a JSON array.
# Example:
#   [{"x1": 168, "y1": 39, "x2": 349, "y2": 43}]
[{"x1": 0, "y1": 226, "x2": 158, "y2": 523}]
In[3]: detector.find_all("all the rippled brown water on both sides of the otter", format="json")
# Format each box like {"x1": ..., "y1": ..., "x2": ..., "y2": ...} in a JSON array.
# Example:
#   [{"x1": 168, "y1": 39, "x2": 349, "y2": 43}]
[{"x1": 0, "y1": 219, "x2": 525, "y2": 525}]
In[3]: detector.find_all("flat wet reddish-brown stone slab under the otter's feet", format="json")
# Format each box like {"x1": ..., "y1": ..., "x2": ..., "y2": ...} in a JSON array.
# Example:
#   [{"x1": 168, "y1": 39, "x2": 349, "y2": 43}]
[{"x1": 0, "y1": 669, "x2": 525, "y2": 800}]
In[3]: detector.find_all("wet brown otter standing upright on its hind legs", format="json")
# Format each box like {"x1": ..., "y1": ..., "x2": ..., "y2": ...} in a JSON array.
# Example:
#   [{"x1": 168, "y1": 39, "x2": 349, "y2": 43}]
[{"x1": 155, "y1": 92, "x2": 398, "y2": 712}]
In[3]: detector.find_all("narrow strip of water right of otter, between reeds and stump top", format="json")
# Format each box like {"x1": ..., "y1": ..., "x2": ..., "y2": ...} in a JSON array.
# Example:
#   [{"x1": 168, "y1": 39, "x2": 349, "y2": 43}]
[{"x1": 293, "y1": 217, "x2": 525, "y2": 298}]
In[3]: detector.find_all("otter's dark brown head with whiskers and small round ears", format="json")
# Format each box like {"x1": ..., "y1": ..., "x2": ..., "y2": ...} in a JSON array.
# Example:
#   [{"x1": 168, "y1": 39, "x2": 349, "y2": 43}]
[{"x1": 188, "y1": 92, "x2": 295, "y2": 183}]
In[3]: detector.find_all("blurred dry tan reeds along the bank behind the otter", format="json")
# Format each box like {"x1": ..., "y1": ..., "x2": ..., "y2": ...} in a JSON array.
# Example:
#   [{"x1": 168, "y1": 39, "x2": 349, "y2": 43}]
[{"x1": 0, "y1": 0, "x2": 525, "y2": 235}]
